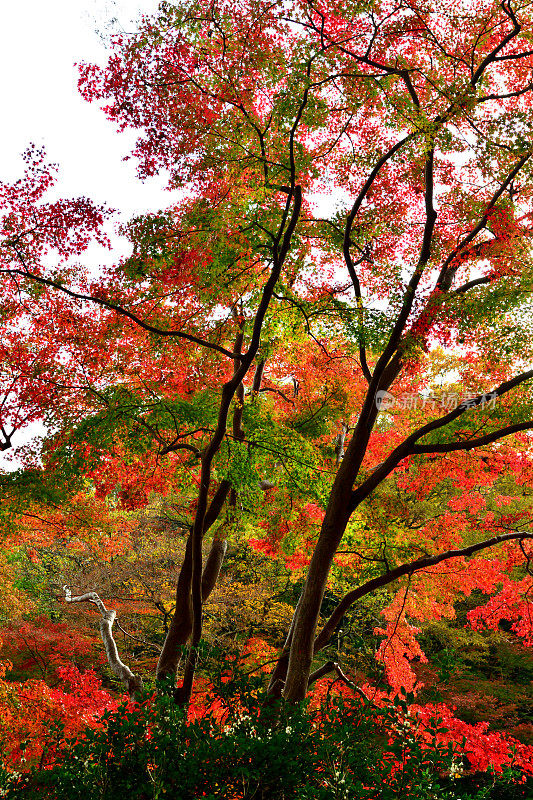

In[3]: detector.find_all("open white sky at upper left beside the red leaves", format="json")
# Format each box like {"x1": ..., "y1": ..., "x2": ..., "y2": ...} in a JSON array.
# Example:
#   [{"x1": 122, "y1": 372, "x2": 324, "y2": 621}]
[{"x1": 0, "y1": 0, "x2": 170, "y2": 469}]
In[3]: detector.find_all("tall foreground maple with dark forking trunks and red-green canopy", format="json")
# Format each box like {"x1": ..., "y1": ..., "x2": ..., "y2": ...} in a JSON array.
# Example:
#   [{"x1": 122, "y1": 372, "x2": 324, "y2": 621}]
[{"x1": 1, "y1": 0, "x2": 533, "y2": 702}]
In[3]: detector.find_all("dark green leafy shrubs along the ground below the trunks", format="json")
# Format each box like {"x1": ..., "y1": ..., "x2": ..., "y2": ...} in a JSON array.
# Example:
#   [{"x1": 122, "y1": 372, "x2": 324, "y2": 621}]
[{"x1": 0, "y1": 681, "x2": 527, "y2": 800}]
